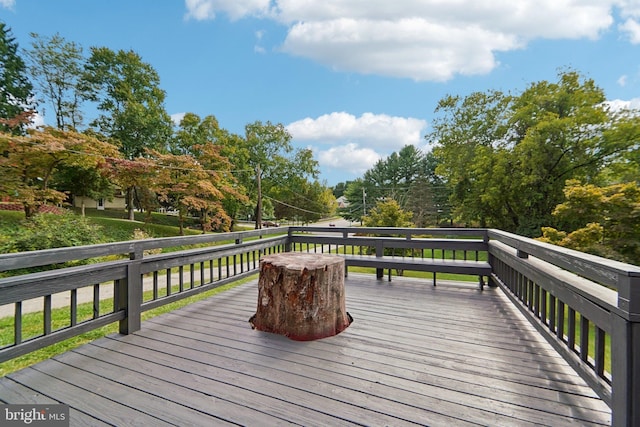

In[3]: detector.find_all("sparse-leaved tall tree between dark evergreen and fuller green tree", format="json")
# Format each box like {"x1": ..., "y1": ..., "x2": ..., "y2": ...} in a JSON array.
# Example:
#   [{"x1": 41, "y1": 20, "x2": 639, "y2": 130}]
[{"x1": 28, "y1": 33, "x2": 86, "y2": 130}]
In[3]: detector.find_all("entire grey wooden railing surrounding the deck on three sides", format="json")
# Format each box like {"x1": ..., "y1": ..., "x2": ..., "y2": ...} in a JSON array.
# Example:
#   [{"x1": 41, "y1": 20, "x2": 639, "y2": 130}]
[{"x1": 0, "y1": 227, "x2": 640, "y2": 426}]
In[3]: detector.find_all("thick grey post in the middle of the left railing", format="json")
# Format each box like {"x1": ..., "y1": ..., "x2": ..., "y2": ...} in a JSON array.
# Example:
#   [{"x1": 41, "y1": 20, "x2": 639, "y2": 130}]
[{"x1": 118, "y1": 245, "x2": 143, "y2": 335}]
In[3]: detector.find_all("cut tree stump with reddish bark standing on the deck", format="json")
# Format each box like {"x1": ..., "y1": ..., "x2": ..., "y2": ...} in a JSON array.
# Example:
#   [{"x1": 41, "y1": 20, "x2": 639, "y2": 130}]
[{"x1": 249, "y1": 252, "x2": 353, "y2": 341}]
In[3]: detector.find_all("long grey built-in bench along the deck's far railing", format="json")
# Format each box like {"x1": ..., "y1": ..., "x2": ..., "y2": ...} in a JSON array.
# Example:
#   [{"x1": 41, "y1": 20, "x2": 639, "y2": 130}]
[{"x1": 343, "y1": 255, "x2": 491, "y2": 289}]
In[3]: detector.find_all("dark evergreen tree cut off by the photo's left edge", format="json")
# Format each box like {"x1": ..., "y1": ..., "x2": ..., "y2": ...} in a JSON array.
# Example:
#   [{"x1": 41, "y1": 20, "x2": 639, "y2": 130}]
[{"x1": 0, "y1": 22, "x2": 35, "y2": 134}]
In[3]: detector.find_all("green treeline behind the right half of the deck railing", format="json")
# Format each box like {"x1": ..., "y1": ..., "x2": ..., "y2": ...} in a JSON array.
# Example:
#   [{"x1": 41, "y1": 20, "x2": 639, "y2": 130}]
[{"x1": 336, "y1": 70, "x2": 640, "y2": 264}]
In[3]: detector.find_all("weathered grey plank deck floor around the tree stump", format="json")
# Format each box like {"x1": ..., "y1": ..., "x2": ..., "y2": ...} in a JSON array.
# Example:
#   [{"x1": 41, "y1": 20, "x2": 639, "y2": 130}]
[{"x1": 0, "y1": 274, "x2": 611, "y2": 426}]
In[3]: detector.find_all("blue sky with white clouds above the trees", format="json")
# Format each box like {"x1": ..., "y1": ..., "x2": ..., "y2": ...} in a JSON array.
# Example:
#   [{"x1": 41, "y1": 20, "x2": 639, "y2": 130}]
[{"x1": 0, "y1": 0, "x2": 640, "y2": 185}]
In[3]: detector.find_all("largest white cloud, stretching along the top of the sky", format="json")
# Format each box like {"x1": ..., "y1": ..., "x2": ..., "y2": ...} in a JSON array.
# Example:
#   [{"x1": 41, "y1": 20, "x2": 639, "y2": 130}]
[{"x1": 185, "y1": 0, "x2": 620, "y2": 81}]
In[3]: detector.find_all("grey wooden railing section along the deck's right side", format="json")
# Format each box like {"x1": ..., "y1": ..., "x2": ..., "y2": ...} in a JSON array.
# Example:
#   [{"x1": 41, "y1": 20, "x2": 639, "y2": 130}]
[{"x1": 488, "y1": 230, "x2": 640, "y2": 426}]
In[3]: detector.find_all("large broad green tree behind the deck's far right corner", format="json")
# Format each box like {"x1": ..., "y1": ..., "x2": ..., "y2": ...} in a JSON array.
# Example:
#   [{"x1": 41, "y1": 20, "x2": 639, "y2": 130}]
[{"x1": 427, "y1": 71, "x2": 637, "y2": 236}]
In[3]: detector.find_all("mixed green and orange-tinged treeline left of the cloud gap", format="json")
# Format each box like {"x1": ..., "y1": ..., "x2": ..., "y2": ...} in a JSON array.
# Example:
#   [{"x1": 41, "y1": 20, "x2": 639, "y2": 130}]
[{"x1": 0, "y1": 22, "x2": 335, "y2": 239}]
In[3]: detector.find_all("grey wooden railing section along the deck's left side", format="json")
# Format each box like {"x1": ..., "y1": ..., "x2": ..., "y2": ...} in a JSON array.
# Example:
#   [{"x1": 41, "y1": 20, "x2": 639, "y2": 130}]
[{"x1": 0, "y1": 228, "x2": 287, "y2": 362}]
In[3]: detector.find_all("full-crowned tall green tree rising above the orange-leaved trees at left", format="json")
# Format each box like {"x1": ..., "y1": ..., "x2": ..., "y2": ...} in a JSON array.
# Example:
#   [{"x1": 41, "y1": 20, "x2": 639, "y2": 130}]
[{"x1": 83, "y1": 47, "x2": 173, "y2": 220}]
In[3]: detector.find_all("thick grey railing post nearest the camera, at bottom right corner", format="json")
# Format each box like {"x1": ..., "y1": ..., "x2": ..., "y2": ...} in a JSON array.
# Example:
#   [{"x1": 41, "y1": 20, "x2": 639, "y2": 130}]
[{"x1": 611, "y1": 276, "x2": 640, "y2": 427}]
